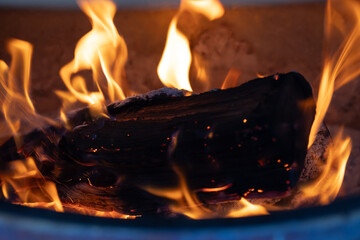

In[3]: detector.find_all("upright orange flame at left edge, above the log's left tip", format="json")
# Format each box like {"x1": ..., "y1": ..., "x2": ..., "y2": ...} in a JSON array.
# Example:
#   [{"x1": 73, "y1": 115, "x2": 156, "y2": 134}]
[{"x1": 0, "y1": 39, "x2": 55, "y2": 135}]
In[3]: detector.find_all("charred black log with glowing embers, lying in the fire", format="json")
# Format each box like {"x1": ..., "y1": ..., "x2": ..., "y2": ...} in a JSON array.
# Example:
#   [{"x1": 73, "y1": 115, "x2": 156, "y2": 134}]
[{"x1": 0, "y1": 72, "x2": 315, "y2": 215}]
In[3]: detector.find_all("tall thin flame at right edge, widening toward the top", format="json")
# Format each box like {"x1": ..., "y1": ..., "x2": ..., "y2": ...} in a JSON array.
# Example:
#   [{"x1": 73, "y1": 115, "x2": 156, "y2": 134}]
[{"x1": 308, "y1": 0, "x2": 360, "y2": 147}]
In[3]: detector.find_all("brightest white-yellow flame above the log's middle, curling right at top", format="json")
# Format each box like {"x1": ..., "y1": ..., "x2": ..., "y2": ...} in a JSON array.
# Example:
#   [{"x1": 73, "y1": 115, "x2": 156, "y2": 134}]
[{"x1": 157, "y1": 0, "x2": 224, "y2": 91}]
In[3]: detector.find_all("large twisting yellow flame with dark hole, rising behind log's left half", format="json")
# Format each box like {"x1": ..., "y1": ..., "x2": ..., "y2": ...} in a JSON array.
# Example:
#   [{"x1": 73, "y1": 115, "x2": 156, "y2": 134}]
[{"x1": 57, "y1": 0, "x2": 128, "y2": 117}]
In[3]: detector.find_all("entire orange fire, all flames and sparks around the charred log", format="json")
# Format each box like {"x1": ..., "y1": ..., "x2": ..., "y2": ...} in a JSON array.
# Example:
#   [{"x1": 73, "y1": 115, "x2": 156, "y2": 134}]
[{"x1": 0, "y1": 0, "x2": 360, "y2": 219}]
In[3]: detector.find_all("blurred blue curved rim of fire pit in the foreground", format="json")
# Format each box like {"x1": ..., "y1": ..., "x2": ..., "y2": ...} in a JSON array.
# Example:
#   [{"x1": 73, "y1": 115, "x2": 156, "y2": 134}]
[{"x1": 0, "y1": 196, "x2": 360, "y2": 240}]
